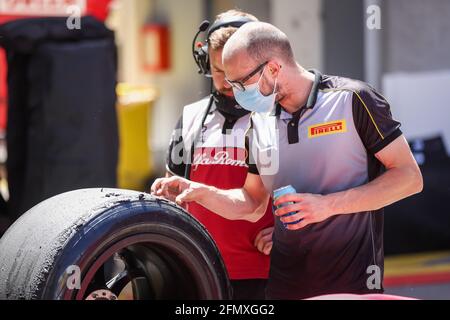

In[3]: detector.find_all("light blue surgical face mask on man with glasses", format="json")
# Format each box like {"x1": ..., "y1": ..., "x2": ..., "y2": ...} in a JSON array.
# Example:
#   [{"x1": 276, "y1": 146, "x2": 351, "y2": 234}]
[{"x1": 233, "y1": 68, "x2": 277, "y2": 112}]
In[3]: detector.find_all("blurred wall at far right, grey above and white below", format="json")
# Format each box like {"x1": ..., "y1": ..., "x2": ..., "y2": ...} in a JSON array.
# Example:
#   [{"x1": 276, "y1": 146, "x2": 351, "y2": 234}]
[{"x1": 382, "y1": 0, "x2": 450, "y2": 156}]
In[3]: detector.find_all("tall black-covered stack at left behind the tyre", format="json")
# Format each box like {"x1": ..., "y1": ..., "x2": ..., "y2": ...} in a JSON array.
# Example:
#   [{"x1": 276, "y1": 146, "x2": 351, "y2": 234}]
[{"x1": 0, "y1": 17, "x2": 118, "y2": 220}]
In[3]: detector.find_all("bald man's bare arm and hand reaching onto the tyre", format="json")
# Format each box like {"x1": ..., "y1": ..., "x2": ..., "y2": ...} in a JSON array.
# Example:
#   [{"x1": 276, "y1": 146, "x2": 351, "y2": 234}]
[{"x1": 151, "y1": 173, "x2": 269, "y2": 222}]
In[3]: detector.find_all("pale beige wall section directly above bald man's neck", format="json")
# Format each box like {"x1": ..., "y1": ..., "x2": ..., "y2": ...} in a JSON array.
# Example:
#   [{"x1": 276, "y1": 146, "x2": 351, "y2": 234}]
[{"x1": 271, "y1": 0, "x2": 323, "y2": 70}]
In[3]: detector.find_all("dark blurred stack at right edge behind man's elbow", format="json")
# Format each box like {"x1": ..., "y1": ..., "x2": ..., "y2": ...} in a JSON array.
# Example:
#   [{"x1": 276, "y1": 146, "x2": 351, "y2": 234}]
[{"x1": 384, "y1": 136, "x2": 450, "y2": 255}]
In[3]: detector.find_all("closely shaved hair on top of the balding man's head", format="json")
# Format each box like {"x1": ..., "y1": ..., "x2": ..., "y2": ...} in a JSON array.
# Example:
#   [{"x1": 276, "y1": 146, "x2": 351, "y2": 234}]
[{"x1": 223, "y1": 22, "x2": 295, "y2": 65}]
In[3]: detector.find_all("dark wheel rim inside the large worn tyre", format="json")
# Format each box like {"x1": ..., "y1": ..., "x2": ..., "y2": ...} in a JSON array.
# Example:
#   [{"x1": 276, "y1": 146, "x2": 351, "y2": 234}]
[{"x1": 70, "y1": 234, "x2": 223, "y2": 300}]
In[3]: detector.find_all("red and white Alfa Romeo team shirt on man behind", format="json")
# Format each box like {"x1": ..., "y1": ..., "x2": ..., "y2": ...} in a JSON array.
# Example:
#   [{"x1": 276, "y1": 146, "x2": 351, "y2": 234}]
[{"x1": 167, "y1": 99, "x2": 273, "y2": 280}]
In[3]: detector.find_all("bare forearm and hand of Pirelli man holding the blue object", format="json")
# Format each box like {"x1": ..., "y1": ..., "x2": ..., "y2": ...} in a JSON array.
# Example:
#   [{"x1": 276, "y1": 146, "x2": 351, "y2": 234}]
[{"x1": 275, "y1": 135, "x2": 423, "y2": 229}]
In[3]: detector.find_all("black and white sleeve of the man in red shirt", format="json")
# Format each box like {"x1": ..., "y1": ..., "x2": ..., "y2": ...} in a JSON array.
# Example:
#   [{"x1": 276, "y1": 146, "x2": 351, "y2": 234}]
[{"x1": 166, "y1": 116, "x2": 186, "y2": 177}]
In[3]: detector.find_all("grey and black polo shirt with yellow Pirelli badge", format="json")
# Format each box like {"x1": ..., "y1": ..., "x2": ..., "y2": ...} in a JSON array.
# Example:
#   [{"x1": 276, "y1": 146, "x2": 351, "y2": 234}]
[{"x1": 247, "y1": 72, "x2": 402, "y2": 299}]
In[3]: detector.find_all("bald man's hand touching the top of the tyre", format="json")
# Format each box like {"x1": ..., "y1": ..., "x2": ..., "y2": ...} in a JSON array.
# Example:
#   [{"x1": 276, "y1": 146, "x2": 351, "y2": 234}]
[{"x1": 151, "y1": 176, "x2": 205, "y2": 205}]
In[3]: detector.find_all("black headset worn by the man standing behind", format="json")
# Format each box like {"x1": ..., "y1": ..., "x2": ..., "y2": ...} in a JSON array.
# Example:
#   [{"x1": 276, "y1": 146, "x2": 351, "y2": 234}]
[{"x1": 192, "y1": 17, "x2": 254, "y2": 77}]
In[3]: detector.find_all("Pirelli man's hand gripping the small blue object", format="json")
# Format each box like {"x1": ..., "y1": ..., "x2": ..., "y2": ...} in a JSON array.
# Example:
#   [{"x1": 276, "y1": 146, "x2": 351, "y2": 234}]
[{"x1": 274, "y1": 193, "x2": 333, "y2": 230}]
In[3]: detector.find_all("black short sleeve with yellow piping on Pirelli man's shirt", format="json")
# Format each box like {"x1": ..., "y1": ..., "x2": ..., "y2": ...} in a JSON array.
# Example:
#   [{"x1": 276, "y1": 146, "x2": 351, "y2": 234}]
[{"x1": 352, "y1": 85, "x2": 402, "y2": 154}]
